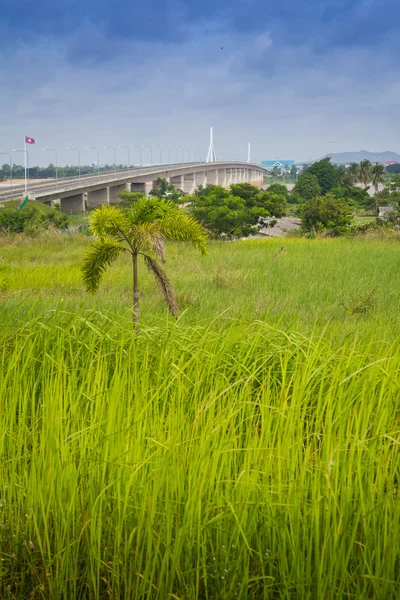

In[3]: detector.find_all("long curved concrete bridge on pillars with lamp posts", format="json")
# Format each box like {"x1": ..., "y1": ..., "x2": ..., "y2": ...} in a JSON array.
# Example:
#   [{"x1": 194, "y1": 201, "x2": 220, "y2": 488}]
[{"x1": 0, "y1": 161, "x2": 269, "y2": 214}]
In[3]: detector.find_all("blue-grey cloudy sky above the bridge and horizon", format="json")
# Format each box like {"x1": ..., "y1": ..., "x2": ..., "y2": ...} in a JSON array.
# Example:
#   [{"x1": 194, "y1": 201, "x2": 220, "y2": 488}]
[{"x1": 0, "y1": 0, "x2": 400, "y2": 164}]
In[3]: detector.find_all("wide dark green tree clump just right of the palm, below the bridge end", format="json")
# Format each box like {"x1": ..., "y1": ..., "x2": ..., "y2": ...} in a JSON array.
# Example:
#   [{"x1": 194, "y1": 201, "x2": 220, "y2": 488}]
[{"x1": 187, "y1": 183, "x2": 287, "y2": 239}]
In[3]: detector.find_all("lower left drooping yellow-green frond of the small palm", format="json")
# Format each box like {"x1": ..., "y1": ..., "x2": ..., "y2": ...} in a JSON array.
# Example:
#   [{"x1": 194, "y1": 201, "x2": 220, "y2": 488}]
[{"x1": 82, "y1": 238, "x2": 127, "y2": 293}]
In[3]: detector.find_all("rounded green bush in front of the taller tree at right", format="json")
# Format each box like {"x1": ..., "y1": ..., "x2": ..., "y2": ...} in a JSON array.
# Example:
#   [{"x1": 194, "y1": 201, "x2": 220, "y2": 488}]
[{"x1": 302, "y1": 194, "x2": 352, "y2": 233}]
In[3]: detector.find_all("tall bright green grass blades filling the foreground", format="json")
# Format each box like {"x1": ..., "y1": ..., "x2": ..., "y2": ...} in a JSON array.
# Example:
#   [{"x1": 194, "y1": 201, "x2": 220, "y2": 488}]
[{"x1": 0, "y1": 308, "x2": 400, "y2": 600}]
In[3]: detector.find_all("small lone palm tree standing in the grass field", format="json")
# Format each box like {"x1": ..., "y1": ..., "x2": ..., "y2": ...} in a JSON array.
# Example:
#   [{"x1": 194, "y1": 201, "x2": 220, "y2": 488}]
[{"x1": 82, "y1": 198, "x2": 207, "y2": 325}]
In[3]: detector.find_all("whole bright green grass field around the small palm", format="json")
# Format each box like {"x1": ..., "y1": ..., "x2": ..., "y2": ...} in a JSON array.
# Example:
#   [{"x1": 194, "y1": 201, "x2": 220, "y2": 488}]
[{"x1": 0, "y1": 235, "x2": 400, "y2": 600}]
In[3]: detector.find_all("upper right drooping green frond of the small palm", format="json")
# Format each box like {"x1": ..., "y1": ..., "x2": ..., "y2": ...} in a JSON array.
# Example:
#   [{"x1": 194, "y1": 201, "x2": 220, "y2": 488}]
[{"x1": 160, "y1": 207, "x2": 207, "y2": 254}]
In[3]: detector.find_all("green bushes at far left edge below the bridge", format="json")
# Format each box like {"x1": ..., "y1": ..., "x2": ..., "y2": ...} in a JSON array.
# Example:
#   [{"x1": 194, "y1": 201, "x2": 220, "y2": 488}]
[{"x1": 0, "y1": 202, "x2": 69, "y2": 234}]
